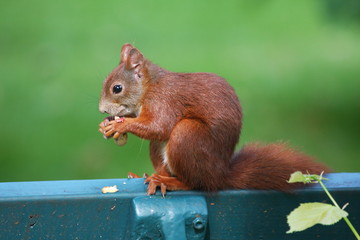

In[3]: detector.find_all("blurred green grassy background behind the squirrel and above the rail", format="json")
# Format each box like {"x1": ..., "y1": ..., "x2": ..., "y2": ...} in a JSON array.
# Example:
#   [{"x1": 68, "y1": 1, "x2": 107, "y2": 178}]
[{"x1": 0, "y1": 0, "x2": 360, "y2": 181}]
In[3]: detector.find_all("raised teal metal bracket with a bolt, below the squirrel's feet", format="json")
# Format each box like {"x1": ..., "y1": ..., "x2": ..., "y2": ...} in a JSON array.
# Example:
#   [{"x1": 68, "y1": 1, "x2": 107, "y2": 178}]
[{"x1": 129, "y1": 196, "x2": 208, "y2": 239}]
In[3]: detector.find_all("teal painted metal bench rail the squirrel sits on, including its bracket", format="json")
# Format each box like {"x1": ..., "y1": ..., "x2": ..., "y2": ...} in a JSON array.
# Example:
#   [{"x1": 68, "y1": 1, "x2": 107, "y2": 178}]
[{"x1": 0, "y1": 173, "x2": 360, "y2": 240}]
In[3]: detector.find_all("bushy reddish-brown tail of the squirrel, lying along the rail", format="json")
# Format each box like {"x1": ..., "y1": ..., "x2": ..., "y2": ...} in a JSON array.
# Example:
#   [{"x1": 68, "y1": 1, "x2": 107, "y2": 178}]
[{"x1": 227, "y1": 143, "x2": 330, "y2": 191}]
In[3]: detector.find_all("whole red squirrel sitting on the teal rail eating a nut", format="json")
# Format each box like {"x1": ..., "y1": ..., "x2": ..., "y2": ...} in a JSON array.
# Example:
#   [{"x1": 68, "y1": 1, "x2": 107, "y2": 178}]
[{"x1": 99, "y1": 44, "x2": 329, "y2": 195}]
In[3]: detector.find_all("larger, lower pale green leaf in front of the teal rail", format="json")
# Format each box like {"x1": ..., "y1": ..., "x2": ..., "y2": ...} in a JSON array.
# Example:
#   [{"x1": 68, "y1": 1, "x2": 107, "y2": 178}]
[{"x1": 286, "y1": 202, "x2": 348, "y2": 233}]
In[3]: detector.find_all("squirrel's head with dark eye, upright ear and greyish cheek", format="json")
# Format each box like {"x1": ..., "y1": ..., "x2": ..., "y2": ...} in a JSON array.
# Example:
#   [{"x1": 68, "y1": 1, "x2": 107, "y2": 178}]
[{"x1": 99, "y1": 44, "x2": 148, "y2": 117}]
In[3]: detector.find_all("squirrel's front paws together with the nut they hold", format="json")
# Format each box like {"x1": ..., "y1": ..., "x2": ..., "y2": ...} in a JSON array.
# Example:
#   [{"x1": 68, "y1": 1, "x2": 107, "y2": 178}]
[{"x1": 99, "y1": 116, "x2": 127, "y2": 146}]
